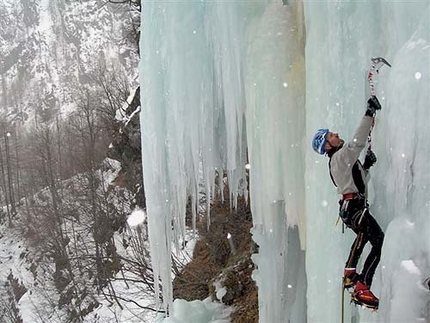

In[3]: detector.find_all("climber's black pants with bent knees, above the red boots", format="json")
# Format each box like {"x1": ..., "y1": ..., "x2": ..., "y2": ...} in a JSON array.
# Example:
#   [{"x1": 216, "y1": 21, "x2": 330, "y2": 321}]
[{"x1": 340, "y1": 197, "x2": 384, "y2": 287}]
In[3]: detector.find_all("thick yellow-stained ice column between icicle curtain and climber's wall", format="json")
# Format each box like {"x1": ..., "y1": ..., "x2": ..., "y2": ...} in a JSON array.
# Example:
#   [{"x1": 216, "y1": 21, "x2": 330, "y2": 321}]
[{"x1": 246, "y1": 2, "x2": 307, "y2": 323}]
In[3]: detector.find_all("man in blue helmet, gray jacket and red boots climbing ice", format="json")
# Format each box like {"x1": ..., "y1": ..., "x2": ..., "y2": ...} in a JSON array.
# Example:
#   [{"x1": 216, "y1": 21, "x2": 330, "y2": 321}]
[{"x1": 312, "y1": 96, "x2": 384, "y2": 308}]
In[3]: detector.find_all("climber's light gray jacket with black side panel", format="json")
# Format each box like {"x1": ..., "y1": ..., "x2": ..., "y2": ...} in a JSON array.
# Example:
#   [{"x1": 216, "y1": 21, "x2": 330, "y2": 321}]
[{"x1": 329, "y1": 116, "x2": 373, "y2": 195}]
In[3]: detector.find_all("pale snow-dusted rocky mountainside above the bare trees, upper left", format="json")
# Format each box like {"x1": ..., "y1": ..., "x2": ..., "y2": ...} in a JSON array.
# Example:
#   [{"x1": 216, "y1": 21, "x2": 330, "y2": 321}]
[{"x1": 0, "y1": 0, "x2": 139, "y2": 122}]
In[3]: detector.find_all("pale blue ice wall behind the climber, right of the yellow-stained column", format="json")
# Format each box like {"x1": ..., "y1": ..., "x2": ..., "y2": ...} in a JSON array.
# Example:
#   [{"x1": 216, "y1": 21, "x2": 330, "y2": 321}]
[{"x1": 305, "y1": 1, "x2": 430, "y2": 322}]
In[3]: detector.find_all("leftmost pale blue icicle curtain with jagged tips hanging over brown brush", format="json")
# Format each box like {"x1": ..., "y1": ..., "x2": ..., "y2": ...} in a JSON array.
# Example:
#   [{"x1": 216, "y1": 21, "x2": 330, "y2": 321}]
[{"x1": 140, "y1": 1, "x2": 247, "y2": 309}]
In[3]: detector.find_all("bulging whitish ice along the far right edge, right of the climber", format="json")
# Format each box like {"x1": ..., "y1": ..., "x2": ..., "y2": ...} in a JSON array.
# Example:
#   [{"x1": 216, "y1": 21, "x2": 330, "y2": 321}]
[{"x1": 375, "y1": 6, "x2": 430, "y2": 322}]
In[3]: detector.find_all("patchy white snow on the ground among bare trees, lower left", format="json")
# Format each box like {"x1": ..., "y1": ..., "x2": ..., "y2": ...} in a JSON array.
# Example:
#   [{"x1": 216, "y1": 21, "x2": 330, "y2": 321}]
[{"x1": 0, "y1": 158, "x2": 203, "y2": 323}]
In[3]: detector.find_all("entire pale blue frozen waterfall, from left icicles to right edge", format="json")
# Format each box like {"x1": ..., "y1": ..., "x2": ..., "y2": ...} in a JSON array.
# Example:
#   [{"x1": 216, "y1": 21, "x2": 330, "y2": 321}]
[{"x1": 140, "y1": 0, "x2": 430, "y2": 323}]
